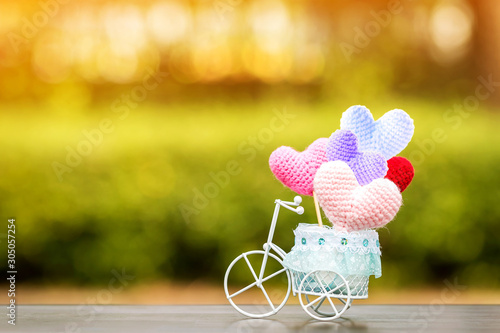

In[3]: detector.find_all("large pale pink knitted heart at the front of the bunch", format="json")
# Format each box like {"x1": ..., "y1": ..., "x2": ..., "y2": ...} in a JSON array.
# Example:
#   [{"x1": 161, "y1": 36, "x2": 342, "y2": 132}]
[{"x1": 314, "y1": 161, "x2": 402, "y2": 232}]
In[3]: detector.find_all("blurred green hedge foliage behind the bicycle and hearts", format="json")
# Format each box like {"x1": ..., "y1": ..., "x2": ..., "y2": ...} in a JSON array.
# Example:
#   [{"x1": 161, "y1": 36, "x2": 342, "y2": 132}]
[{"x1": 0, "y1": 97, "x2": 500, "y2": 287}]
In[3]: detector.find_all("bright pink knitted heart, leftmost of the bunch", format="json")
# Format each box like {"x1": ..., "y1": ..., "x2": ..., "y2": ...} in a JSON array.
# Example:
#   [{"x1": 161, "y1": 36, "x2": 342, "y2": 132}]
[{"x1": 269, "y1": 138, "x2": 328, "y2": 195}]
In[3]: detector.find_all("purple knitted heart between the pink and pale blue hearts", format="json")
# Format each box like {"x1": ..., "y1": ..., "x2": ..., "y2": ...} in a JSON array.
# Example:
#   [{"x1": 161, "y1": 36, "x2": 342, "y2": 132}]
[{"x1": 326, "y1": 130, "x2": 388, "y2": 186}]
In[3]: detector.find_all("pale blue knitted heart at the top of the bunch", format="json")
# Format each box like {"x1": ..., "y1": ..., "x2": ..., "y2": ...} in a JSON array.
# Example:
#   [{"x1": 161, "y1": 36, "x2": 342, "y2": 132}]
[{"x1": 340, "y1": 105, "x2": 415, "y2": 160}]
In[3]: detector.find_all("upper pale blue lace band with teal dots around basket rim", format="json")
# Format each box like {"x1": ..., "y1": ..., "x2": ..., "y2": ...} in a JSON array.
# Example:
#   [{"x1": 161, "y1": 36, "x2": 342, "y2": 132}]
[{"x1": 293, "y1": 223, "x2": 381, "y2": 255}]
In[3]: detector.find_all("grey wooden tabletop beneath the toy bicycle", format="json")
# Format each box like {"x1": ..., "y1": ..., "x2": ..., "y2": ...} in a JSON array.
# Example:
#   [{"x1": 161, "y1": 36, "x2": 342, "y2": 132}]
[{"x1": 0, "y1": 304, "x2": 500, "y2": 333}]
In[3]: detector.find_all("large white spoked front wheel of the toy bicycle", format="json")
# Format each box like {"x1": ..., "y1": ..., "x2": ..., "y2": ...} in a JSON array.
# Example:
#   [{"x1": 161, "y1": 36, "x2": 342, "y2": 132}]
[{"x1": 224, "y1": 250, "x2": 291, "y2": 318}]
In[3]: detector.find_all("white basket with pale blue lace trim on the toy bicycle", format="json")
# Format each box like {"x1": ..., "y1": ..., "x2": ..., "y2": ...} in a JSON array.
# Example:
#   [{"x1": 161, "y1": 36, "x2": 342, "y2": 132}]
[{"x1": 283, "y1": 223, "x2": 382, "y2": 299}]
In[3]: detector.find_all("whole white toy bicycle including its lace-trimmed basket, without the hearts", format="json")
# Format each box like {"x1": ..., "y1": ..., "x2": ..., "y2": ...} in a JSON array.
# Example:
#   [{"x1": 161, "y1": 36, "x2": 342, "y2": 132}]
[{"x1": 224, "y1": 196, "x2": 380, "y2": 320}]
